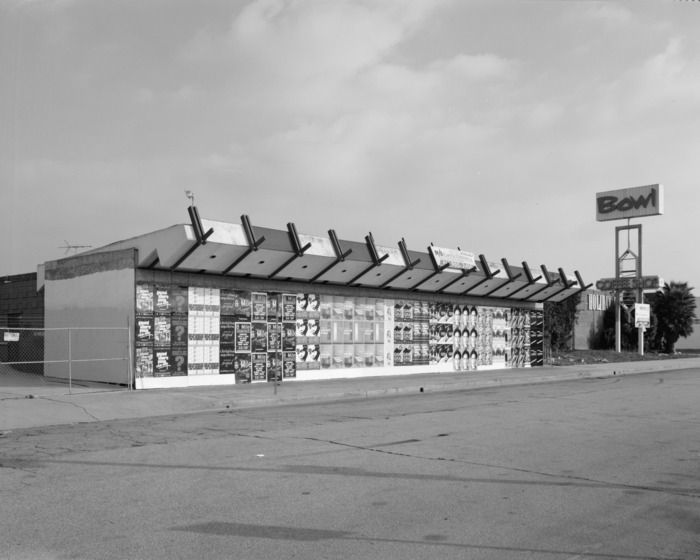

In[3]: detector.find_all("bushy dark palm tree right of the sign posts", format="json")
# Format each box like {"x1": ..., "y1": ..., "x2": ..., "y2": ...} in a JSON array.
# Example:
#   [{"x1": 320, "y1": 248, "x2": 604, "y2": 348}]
[{"x1": 651, "y1": 282, "x2": 696, "y2": 354}]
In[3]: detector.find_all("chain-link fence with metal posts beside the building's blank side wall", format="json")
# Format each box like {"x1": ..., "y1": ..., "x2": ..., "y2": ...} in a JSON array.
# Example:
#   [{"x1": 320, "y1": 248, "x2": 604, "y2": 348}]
[{"x1": 0, "y1": 325, "x2": 133, "y2": 400}]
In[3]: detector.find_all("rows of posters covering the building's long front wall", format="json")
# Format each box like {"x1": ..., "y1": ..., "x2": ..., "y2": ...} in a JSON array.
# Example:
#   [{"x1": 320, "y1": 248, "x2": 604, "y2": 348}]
[{"x1": 135, "y1": 283, "x2": 542, "y2": 383}]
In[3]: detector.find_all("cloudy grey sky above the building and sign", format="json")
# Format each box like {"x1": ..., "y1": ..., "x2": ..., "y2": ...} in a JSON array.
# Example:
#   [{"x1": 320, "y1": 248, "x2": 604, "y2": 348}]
[{"x1": 0, "y1": 0, "x2": 700, "y2": 288}]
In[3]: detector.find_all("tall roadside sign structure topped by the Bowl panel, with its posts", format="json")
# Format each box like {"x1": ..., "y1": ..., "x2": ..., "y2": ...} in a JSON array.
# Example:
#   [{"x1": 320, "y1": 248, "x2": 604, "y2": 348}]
[{"x1": 596, "y1": 184, "x2": 664, "y2": 355}]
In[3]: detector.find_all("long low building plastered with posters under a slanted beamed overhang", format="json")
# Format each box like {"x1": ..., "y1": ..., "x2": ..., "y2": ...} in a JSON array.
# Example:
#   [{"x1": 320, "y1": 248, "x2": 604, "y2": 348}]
[{"x1": 6, "y1": 207, "x2": 587, "y2": 389}]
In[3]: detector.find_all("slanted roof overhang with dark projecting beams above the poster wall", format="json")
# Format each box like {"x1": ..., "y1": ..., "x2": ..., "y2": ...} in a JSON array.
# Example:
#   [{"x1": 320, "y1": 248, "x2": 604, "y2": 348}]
[{"x1": 91, "y1": 207, "x2": 590, "y2": 303}]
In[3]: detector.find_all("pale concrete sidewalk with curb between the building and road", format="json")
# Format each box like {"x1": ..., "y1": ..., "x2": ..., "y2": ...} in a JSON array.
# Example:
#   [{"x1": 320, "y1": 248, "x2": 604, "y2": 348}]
[{"x1": 0, "y1": 358, "x2": 700, "y2": 435}]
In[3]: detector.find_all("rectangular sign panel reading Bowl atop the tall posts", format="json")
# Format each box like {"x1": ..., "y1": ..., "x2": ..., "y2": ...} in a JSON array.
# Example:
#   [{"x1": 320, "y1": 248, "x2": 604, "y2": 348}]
[{"x1": 595, "y1": 185, "x2": 664, "y2": 222}]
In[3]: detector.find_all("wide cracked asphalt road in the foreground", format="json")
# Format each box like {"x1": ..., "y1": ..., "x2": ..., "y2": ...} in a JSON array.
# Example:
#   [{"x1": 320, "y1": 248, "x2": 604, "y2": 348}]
[{"x1": 0, "y1": 370, "x2": 700, "y2": 560}]
